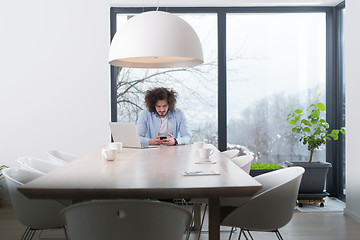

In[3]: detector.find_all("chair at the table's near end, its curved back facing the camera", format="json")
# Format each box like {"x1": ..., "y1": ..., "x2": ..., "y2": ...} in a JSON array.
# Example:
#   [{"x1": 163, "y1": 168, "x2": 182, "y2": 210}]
[{"x1": 60, "y1": 200, "x2": 191, "y2": 240}]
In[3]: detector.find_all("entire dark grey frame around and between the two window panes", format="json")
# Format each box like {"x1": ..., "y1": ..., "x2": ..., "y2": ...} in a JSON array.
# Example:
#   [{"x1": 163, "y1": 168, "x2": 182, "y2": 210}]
[{"x1": 110, "y1": 2, "x2": 345, "y2": 200}]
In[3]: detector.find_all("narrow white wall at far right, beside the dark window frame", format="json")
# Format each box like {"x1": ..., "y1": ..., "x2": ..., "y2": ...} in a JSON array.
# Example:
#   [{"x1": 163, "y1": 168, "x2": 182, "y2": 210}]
[{"x1": 345, "y1": 0, "x2": 360, "y2": 222}]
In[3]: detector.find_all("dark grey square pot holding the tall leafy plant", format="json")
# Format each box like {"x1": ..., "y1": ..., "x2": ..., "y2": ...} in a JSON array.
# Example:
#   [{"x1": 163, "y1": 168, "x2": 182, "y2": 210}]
[{"x1": 285, "y1": 161, "x2": 331, "y2": 199}]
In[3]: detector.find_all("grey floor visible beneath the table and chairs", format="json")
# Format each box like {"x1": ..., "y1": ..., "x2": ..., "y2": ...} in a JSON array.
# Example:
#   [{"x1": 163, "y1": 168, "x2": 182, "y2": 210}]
[{"x1": 0, "y1": 202, "x2": 360, "y2": 240}]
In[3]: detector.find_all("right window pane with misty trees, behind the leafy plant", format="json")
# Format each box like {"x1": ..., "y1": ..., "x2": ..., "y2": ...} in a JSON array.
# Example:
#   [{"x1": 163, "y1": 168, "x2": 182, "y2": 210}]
[{"x1": 226, "y1": 13, "x2": 326, "y2": 164}]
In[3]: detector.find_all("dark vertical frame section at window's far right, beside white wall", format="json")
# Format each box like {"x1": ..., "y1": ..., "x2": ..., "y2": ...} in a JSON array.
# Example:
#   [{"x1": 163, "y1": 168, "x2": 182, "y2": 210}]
[{"x1": 326, "y1": 2, "x2": 346, "y2": 201}]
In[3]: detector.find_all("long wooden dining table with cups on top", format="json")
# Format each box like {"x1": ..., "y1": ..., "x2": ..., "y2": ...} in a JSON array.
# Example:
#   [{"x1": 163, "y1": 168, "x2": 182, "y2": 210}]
[{"x1": 18, "y1": 144, "x2": 261, "y2": 240}]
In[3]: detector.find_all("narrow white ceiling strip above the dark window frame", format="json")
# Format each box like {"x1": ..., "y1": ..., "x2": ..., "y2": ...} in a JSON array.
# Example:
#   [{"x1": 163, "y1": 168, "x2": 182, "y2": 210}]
[{"x1": 114, "y1": 0, "x2": 344, "y2": 7}]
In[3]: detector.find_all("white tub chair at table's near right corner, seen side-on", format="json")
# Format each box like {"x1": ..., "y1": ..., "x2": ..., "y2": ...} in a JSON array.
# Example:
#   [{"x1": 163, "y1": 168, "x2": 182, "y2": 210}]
[{"x1": 220, "y1": 167, "x2": 305, "y2": 239}]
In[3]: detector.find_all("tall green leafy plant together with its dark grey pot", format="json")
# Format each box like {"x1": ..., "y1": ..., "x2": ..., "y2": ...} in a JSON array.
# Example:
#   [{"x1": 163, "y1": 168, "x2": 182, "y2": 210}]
[{"x1": 286, "y1": 94, "x2": 345, "y2": 206}]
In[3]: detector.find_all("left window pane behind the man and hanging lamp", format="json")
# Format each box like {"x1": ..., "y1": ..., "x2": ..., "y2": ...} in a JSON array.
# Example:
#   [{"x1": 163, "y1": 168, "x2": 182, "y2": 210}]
[{"x1": 117, "y1": 13, "x2": 218, "y2": 146}]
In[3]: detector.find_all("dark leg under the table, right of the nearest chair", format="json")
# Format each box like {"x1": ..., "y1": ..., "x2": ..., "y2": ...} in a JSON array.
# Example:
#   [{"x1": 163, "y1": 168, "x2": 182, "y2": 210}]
[{"x1": 209, "y1": 198, "x2": 220, "y2": 240}]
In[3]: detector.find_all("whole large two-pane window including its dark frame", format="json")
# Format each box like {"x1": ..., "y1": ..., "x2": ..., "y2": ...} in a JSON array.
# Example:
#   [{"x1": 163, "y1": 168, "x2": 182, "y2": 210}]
[{"x1": 110, "y1": 4, "x2": 345, "y2": 199}]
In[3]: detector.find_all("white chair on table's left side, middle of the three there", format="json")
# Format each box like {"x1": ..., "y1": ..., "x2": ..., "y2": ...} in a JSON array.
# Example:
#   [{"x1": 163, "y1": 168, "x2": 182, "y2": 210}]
[{"x1": 17, "y1": 157, "x2": 64, "y2": 174}]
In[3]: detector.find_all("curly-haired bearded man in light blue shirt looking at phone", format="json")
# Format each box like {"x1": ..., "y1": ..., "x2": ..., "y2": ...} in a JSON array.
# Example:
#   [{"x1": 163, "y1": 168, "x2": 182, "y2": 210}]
[{"x1": 136, "y1": 88, "x2": 191, "y2": 147}]
